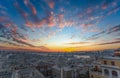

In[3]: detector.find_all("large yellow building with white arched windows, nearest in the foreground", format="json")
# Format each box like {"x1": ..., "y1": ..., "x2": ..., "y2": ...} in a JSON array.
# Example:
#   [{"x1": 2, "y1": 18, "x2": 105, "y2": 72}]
[{"x1": 89, "y1": 56, "x2": 120, "y2": 78}]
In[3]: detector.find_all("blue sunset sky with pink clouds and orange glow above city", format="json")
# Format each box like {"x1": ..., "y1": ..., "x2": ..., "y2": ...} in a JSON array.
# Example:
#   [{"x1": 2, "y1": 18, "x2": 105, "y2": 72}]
[{"x1": 0, "y1": 0, "x2": 120, "y2": 52}]
